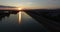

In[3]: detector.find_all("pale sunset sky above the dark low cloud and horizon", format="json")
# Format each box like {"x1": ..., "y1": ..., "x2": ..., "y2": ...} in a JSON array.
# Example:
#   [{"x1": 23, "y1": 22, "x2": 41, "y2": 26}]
[{"x1": 0, "y1": 0, "x2": 60, "y2": 9}]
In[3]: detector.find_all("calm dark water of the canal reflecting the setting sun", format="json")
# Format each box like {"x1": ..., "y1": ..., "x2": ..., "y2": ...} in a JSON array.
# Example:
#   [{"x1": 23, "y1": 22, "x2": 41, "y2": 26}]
[{"x1": 0, "y1": 12, "x2": 47, "y2": 32}]
